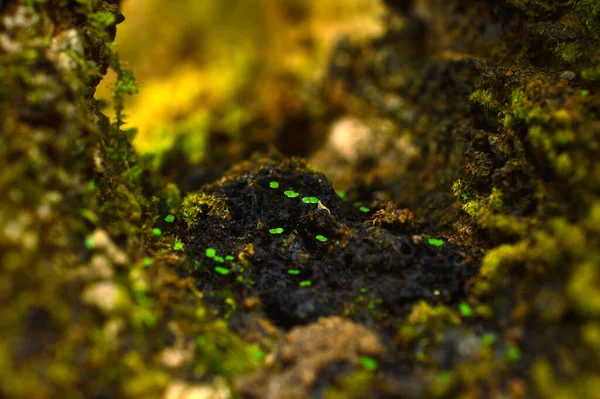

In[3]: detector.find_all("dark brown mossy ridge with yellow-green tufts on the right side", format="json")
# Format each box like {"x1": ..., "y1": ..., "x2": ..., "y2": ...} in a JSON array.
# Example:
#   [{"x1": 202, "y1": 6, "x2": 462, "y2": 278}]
[{"x1": 328, "y1": 0, "x2": 600, "y2": 396}]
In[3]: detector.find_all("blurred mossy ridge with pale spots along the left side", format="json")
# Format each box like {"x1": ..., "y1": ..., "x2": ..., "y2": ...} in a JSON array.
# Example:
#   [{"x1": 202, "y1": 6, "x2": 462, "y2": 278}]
[{"x1": 0, "y1": 1, "x2": 260, "y2": 398}]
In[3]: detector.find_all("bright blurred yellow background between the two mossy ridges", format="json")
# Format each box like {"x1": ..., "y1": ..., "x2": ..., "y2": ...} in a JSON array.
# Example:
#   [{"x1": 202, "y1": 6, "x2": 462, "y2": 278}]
[{"x1": 97, "y1": 0, "x2": 384, "y2": 162}]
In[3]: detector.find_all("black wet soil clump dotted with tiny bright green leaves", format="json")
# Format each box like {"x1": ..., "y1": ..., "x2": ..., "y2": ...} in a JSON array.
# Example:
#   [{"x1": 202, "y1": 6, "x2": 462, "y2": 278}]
[{"x1": 180, "y1": 158, "x2": 479, "y2": 329}]
